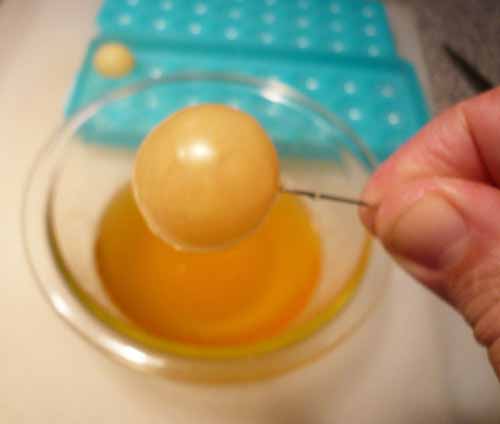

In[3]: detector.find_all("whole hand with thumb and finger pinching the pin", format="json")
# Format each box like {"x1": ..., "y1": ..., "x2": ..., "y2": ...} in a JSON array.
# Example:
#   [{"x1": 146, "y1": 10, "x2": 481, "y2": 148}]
[{"x1": 359, "y1": 88, "x2": 500, "y2": 379}]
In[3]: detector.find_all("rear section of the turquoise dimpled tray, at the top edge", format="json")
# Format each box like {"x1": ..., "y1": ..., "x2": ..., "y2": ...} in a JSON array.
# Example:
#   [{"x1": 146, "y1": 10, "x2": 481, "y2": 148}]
[{"x1": 97, "y1": 0, "x2": 396, "y2": 57}]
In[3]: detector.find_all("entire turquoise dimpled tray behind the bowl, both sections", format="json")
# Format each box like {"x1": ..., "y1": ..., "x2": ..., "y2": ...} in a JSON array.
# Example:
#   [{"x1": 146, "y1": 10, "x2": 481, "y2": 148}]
[{"x1": 66, "y1": 0, "x2": 428, "y2": 160}]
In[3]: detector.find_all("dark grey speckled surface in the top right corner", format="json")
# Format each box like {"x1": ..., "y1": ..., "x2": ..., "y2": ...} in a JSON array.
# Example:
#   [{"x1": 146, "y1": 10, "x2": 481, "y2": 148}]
[{"x1": 387, "y1": 0, "x2": 500, "y2": 111}]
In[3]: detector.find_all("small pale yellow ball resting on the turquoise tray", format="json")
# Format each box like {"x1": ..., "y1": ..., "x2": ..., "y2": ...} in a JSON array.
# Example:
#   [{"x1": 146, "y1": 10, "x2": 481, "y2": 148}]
[{"x1": 94, "y1": 43, "x2": 135, "y2": 78}]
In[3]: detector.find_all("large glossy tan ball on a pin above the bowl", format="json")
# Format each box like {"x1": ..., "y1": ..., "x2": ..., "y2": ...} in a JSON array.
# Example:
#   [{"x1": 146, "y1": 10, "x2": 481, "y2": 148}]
[{"x1": 132, "y1": 104, "x2": 279, "y2": 250}]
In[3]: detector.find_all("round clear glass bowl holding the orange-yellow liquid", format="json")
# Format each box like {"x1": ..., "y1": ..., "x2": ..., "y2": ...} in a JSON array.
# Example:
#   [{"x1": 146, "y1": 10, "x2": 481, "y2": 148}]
[{"x1": 23, "y1": 72, "x2": 388, "y2": 382}]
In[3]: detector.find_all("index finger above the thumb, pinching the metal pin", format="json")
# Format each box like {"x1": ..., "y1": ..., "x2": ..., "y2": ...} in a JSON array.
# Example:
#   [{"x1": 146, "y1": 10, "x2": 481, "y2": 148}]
[{"x1": 361, "y1": 88, "x2": 500, "y2": 228}]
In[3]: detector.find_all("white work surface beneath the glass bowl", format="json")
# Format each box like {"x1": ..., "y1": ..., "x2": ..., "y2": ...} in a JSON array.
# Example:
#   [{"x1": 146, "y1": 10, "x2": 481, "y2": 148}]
[{"x1": 0, "y1": 0, "x2": 500, "y2": 424}]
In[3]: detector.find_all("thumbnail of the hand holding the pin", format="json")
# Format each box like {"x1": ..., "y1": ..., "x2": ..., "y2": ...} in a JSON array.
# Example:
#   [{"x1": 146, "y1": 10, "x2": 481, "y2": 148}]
[{"x1": 383, "y1": 194, "x2": 468, "y2": 270}]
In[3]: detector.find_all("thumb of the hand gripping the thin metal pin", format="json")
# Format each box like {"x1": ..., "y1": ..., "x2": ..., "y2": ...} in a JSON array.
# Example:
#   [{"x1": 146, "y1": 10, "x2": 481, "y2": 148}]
[{"x1": 374, "y1": 178, "x2": 500, "y2": 362}]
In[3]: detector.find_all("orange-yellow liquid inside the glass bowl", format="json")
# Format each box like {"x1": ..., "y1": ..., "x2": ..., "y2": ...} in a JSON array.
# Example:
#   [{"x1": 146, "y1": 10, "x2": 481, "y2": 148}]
[{"x1": 96, "y1": 187, "x2": 321, "y2": 346}]
